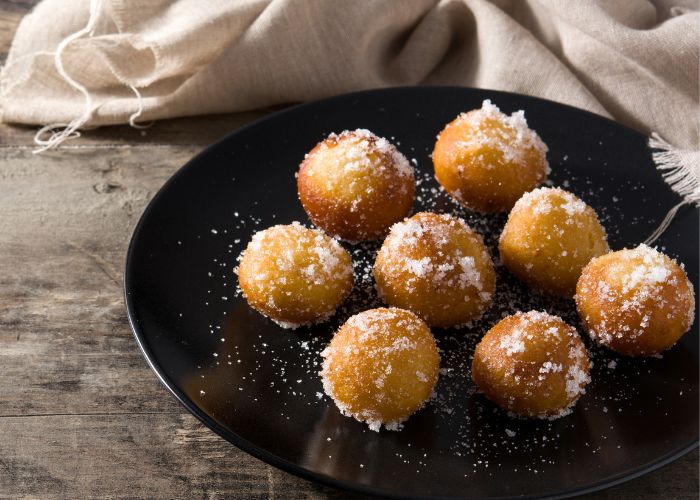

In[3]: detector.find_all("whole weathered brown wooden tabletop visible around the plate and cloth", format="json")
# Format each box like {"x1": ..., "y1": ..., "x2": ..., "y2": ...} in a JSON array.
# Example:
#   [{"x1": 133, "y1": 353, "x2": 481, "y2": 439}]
[{"x1": 0, "y1": 0, "x2": 698, "y2": 499}]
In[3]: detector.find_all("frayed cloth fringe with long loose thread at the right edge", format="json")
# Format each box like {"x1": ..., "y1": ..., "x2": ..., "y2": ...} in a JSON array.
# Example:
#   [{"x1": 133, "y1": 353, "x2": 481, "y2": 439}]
[{"x1": 644, "y1": 132, "x2": 700, "y2": 245}]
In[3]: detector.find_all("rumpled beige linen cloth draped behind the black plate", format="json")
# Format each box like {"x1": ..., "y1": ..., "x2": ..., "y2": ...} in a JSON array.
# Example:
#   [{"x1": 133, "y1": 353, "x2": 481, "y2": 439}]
[{"x1": 0, "y1": 0, "x2": 700, "y2": 149}]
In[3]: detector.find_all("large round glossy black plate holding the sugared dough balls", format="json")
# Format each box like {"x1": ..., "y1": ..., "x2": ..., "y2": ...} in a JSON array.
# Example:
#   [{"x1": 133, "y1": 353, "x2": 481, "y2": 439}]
[{"x1": 125, "y1": 88, "x2": 698, "y2": 498}]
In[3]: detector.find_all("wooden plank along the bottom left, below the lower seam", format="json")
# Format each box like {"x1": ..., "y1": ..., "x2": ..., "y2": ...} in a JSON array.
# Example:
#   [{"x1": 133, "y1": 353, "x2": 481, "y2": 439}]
[{"x1": 0, "y1": 414, "x2": 360, "y2": 499}]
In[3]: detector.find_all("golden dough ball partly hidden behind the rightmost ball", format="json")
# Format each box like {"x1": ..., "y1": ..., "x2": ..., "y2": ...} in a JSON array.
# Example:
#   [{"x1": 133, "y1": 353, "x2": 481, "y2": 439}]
[{"x1": 498, "y1": 188, "x2": 610, "y2": 297}]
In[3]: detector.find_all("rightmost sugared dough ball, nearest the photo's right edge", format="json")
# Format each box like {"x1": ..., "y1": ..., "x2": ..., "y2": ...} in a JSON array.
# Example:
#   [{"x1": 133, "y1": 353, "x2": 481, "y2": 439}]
[{"x1": 575, "y1": 245, "x2": 695, "y2": 356}]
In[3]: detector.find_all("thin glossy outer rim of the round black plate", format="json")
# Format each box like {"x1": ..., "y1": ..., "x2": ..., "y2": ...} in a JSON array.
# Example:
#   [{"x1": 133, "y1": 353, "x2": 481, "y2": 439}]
[{"x1": 122, "y1": 85, "x2": 700, "y2": 500}]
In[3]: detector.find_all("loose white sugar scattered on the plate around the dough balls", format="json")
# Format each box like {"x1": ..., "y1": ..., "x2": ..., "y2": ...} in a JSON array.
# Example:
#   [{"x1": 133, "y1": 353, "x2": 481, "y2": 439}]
[{"x1": 186, "y1": 117, "x2": 698, "y2": 481}]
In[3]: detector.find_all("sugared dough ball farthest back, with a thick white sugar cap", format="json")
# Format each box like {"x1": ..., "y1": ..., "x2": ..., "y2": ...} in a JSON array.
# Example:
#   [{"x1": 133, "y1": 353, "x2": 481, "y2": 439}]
[{"x1": 433, "y1": 100, "x2": 549, "y2": 213}]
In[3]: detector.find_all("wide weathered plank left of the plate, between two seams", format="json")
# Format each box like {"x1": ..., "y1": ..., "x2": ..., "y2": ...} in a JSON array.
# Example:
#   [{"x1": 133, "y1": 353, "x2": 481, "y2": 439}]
[{"x1": 0, "y1": 147, "x2": 189, "y2": 415}]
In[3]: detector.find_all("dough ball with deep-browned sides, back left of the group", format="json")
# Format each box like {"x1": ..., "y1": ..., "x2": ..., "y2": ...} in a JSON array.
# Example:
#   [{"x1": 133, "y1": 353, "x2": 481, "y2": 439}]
[{"x1": 297, "y1": 129, "x2": 416, "y2": 242}]
